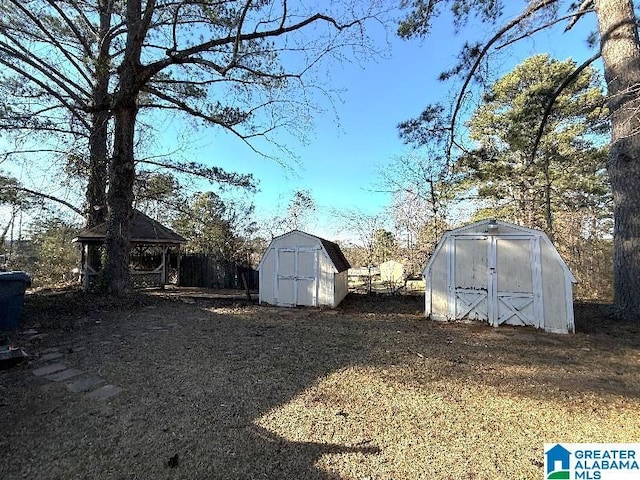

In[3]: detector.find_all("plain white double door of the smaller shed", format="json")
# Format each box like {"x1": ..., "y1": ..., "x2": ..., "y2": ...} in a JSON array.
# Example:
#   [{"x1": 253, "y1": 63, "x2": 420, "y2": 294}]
[{"x1": 274, "y1": 247, "x2": 318, "y2": 307}]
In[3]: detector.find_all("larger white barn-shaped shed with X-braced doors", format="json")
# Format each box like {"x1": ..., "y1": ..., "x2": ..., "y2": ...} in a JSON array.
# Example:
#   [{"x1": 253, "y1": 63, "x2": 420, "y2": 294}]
[{"x1": 424, "y1": 220, "x2": 576, "y2": 333}]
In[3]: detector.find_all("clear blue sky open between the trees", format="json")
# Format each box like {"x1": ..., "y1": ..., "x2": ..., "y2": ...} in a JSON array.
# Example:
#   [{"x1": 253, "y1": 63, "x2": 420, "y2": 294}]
[{"x1": 172, "y1": 4, "x2": 595, "y2": 238}]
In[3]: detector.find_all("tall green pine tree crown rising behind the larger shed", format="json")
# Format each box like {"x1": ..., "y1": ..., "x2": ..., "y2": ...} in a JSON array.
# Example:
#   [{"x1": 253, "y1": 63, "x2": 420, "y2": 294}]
[{"x1": 457, "y1": 55, "x2": 610, "y2": 237}]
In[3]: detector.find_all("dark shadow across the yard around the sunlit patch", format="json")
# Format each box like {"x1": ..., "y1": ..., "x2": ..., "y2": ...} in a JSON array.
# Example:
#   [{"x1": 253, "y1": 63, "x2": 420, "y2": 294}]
[{"x1": 0, "y1": 292, "x2": 640, "y2": 479}]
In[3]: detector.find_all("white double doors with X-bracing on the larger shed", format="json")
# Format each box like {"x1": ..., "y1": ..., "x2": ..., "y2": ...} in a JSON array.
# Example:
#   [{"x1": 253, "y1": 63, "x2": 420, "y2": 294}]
[{"x1": 448, "y1": 235, "x2": 542, "y2": 327}]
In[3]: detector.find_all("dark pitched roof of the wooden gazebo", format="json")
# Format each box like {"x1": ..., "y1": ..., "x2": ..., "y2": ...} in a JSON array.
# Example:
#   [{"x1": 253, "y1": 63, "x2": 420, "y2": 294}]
[{"x1": 73, "y1": 210, "x2": 187, "y2": 245}]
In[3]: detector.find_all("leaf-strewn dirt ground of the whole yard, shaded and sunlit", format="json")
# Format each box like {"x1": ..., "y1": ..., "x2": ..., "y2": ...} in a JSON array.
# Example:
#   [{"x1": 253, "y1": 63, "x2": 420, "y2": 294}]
[{"x1": 0, "y1": 289, "x2": 640, "y2": 480}]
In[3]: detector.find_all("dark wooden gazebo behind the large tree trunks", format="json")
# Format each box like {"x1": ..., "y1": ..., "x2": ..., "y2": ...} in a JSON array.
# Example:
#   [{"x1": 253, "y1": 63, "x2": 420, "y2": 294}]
[{"x1": 73, "y1": 210, "x2": 187, "y2": 290}]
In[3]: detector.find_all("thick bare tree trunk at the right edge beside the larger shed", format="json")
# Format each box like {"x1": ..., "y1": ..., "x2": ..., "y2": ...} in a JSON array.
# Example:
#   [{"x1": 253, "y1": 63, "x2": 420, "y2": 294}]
[{"x1": 594, "y1": 0, "x2": 640, "y2": 321}]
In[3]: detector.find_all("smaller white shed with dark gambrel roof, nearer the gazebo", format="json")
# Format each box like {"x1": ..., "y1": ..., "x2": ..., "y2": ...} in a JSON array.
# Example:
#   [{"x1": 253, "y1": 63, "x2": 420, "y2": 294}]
[{"x1": 258, "y1": 230, "x2": 350, "y2": 308}]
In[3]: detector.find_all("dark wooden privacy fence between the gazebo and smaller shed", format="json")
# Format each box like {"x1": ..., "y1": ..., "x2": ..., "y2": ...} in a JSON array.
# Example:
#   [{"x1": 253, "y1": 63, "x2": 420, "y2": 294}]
[{"x1": 180, "y1": 253, "x2": 258, "y2": 290}]
